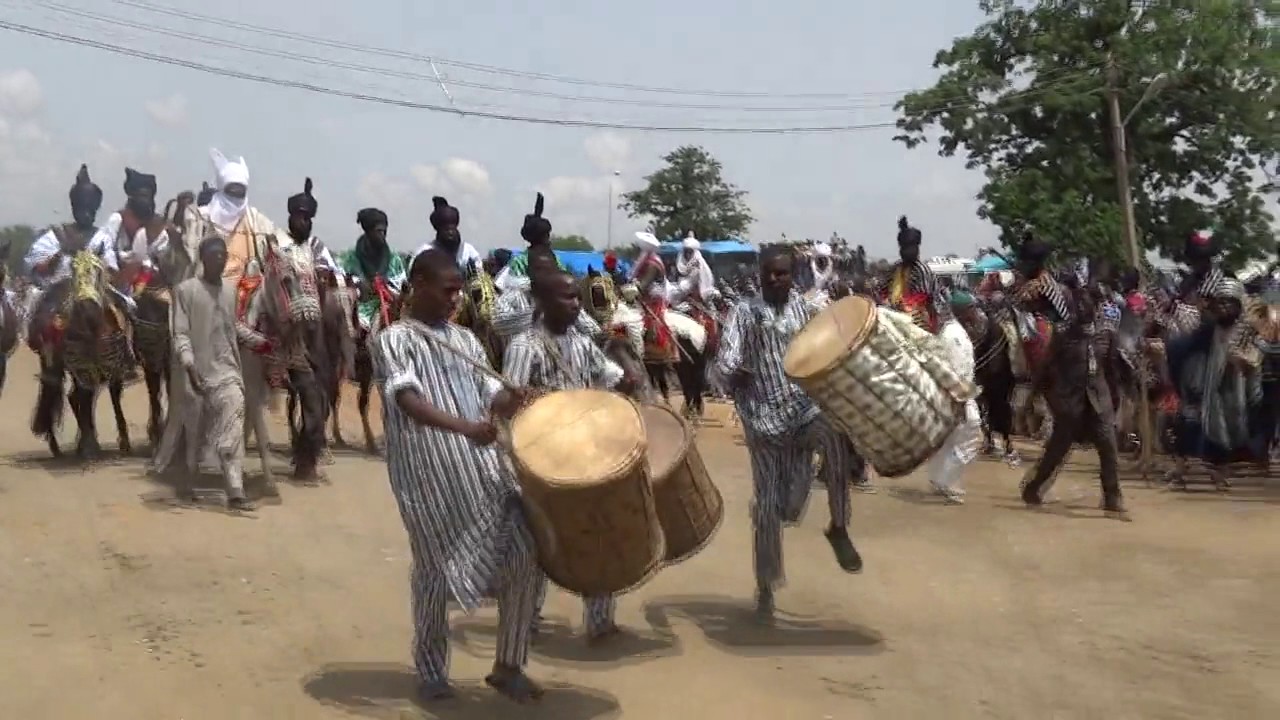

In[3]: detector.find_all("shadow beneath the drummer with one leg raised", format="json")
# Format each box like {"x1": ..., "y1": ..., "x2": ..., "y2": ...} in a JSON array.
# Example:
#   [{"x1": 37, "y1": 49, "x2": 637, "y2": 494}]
[{"x1": 644, "y1": 596, "x2": 884, "y2": 656}]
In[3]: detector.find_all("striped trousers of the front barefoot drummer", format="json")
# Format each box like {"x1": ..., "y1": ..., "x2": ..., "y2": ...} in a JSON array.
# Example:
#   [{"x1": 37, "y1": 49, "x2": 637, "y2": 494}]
[{"x1": 410, "y1": 515, "x2": 545, "y2": 684}]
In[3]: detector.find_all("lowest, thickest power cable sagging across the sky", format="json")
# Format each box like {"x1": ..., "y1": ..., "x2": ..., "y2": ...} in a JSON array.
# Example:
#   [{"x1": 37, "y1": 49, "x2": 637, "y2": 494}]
[{"x1": 0, "y1": 20, "x2": 1105, "y2": 135}]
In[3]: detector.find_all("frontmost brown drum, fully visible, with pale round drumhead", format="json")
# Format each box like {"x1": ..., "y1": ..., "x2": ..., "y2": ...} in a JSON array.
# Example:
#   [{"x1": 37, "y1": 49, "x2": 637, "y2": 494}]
[{"x1": 511, "y1": 389, "x2": 666, "y2": 596}]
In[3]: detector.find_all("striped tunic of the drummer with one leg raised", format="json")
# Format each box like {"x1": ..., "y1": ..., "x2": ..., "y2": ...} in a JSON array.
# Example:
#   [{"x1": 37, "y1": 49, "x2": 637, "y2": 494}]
[{"x1": 716, "y1": 290, "x2": 819, "y2": 437}]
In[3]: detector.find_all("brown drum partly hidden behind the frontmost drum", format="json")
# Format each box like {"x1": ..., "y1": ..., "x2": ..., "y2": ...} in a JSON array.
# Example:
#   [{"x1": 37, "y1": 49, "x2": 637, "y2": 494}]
[{"x1": 640, "y1": 405, "x2": 724, "y2": 564}]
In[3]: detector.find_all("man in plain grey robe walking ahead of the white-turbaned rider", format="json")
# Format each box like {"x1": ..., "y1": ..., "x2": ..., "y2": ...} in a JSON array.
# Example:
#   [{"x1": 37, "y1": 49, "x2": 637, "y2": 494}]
[{"x1": 154, "y1": 234, "x2": 260, "y2": 510}]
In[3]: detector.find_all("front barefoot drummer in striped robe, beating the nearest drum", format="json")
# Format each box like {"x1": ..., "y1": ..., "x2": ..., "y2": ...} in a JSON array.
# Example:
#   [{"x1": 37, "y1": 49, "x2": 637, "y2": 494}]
[{"x1": 372, "y1": 249, "x2": 544, "y2": 702}]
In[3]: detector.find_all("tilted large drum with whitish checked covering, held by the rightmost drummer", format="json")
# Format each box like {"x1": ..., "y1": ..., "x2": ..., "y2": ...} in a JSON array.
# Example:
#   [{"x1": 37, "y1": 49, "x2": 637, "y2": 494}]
[{"x1": 783, "y1": 296, "x2": 978, "y2": 478}]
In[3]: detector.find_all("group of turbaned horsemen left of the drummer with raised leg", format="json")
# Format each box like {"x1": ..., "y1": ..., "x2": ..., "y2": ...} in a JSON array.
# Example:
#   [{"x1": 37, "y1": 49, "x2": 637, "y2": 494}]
[{"x1": 12, "y1": 150, "x2": 742, "y2": 478}]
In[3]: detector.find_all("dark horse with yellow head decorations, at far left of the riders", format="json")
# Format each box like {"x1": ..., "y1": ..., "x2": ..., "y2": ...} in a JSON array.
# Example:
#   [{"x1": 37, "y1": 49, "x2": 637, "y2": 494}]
[{"x1": 31, "y1": 247, "x2": 133, "y2": 460}]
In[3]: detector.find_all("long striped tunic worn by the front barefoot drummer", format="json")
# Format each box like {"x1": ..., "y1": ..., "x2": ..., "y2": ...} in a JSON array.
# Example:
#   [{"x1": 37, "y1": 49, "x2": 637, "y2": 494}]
[{"x1": 372, "y1": 320, "x2": 518, "y2": 611}]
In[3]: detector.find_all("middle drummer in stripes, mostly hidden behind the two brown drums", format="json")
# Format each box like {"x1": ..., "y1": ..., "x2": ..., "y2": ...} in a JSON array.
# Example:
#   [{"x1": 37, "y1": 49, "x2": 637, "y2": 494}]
[{"x1": 503, "y1": 266, "x2": 637, "y2": 642}]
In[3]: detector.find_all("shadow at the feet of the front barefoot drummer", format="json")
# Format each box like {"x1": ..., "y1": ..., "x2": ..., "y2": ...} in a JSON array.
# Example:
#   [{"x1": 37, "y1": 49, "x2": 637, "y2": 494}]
[{"x1": 302, "y1": 662, "x2": 621, "y2": 720}]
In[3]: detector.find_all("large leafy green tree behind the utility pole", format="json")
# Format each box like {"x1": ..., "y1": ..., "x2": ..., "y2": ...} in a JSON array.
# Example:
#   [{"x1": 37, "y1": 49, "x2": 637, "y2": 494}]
[{"x1": 897, "y1": 0, "x2": 1280, "y2": 263}]
